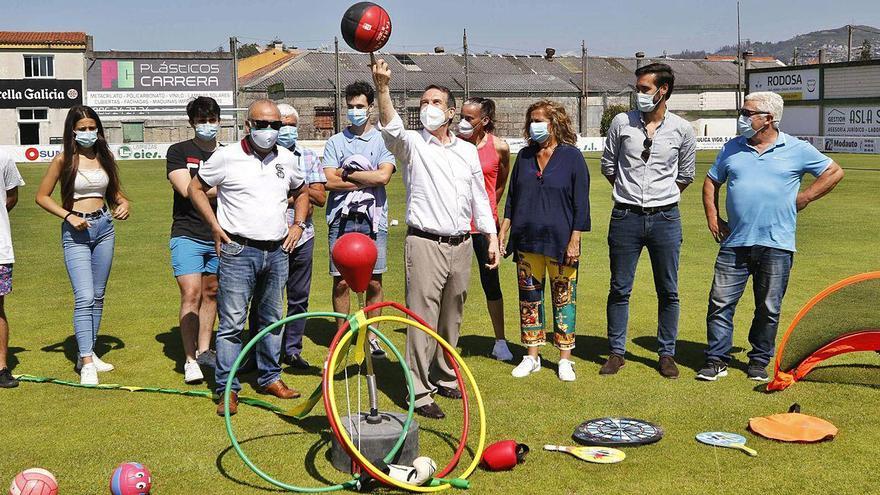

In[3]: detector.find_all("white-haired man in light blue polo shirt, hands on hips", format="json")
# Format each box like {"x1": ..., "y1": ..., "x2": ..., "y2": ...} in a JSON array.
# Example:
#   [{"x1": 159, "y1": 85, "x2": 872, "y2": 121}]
[{"x1": 697, "y1": 91, "x2": 843, "y2": 381}]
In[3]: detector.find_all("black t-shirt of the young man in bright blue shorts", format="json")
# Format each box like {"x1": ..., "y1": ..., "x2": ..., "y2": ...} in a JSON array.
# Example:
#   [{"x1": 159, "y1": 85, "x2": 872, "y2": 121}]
[{"x1": 165, "y1": 139, "x2": 217, "y2": 241}]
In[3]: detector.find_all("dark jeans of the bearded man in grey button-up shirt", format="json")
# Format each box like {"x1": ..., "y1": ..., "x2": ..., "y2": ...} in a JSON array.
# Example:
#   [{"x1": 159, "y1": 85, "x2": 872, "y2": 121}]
[{"x1": 607, "y1": 204, "x2": 681, "y2": 356}]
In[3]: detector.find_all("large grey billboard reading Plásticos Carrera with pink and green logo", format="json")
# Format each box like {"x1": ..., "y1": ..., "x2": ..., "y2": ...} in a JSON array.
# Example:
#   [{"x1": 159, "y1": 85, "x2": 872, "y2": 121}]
[{"x1": 87, "y1": 56, "x2": 235, "y2": 120}]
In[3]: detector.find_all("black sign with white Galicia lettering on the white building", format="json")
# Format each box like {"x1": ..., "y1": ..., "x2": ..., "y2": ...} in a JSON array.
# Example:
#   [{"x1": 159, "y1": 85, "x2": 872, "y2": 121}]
[{"x1": 0, "y1": 79, "x2": 82, "y2": 108}]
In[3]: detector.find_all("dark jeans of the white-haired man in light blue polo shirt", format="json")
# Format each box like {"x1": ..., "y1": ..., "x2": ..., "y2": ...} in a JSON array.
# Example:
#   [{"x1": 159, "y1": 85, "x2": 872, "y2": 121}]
[{"x1": 706, "y1": 246, "x2": 794, "y2": 366}]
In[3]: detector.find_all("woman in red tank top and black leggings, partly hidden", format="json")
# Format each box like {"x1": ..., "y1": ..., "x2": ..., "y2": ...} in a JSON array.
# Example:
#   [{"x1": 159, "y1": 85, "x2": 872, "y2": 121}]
[{"x1": 458, "y1": 96, "x2": 513, "y2": 361}]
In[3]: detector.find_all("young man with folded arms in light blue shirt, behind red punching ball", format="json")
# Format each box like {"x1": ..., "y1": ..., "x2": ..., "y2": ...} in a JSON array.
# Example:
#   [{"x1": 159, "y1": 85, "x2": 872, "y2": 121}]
[{"x1": 323, "y1": 81, "x2": 395, "y2": 357}]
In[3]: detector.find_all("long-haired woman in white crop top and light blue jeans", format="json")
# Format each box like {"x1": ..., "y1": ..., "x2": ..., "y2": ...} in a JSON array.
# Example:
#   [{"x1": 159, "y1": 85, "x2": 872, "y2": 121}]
[{"x1": 37, "y1": 105, "x2": 128, "y2": 385}]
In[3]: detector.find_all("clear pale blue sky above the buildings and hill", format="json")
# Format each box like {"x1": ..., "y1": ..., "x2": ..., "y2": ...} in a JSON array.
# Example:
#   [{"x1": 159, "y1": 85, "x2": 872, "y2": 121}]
[{"x1": 6, "y1": 0, "x2": 880, "y2": 56}]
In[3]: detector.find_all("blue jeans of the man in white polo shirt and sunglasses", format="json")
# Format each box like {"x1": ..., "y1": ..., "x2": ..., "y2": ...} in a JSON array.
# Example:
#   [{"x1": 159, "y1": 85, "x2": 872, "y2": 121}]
[{"x1": 214, "y1": 242, "x2": 288, "y2": 394}]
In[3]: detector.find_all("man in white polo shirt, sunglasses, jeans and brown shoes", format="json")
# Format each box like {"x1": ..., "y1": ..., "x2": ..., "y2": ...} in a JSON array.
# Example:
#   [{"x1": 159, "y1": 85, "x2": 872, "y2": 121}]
[{"x1": 189, "y1": 100, "x2": 309, "y2": 416}]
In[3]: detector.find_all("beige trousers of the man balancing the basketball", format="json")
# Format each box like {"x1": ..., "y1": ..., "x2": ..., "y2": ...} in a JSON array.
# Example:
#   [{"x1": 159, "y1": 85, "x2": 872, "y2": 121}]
[{"x1": 404, "y1": 235, "x2": 473, "y2": 407}]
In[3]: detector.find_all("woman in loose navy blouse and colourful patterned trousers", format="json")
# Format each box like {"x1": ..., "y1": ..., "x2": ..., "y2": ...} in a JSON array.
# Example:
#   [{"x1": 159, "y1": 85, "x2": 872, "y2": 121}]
[{"x1": 499, "y1": 100, "x2": 590, "y2": 382}]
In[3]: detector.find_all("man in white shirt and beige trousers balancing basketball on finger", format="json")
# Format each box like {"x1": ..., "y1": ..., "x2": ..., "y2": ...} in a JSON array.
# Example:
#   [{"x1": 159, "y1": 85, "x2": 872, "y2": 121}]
[{"x1": 371, "y1": 55, "x2": 499, "y2": 419}]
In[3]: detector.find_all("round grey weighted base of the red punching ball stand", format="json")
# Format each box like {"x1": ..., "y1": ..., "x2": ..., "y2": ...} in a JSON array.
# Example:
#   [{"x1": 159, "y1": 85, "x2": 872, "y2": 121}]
[{"x1": 330, "y1": 411, "x2": 419, "y2": 473}]
